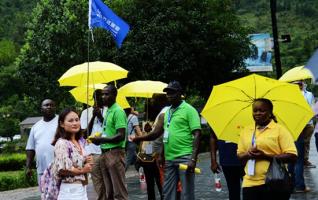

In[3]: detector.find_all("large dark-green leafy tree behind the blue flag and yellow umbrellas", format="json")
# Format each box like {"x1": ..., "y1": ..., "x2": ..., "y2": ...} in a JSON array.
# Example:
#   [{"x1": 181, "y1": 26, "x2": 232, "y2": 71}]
[{"x1": 18, "y1": 0, "x2": 249, "y2": 103}]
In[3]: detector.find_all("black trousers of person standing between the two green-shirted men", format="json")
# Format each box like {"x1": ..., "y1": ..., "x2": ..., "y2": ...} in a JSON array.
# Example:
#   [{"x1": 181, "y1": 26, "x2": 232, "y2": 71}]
[{"x1": 141, "y1": 161, "x2": 162, "y2": 200}]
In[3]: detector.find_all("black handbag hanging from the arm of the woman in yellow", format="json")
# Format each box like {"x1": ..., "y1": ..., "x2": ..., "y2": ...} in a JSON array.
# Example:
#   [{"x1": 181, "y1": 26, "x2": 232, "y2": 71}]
[{"x1": 265, "y1": 158, "x2": 293, "y2": 193}]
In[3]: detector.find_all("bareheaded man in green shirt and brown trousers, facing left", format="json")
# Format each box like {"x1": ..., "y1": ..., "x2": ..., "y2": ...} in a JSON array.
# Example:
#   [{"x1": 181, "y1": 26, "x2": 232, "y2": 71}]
[{"x1": 91, "y1": 85, "x2": 128, "y2": 200}]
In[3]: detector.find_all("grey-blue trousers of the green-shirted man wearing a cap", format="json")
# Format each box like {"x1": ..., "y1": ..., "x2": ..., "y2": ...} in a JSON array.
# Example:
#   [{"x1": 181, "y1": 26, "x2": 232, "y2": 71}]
[{"x1": 163, "y1": 155, "x2": 195, "y2": 200}]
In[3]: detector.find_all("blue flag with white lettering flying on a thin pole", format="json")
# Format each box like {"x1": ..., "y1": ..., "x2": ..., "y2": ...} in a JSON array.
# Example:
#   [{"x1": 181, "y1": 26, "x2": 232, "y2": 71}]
[{"x1": 88, "y1": 0, "x2": 129, "y2": 48}]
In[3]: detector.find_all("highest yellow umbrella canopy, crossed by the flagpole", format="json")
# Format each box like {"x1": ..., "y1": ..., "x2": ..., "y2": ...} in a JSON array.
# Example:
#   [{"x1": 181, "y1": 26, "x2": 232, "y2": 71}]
[{"x1": 58, "y1": 61, "x2": 128, "y2": 86}]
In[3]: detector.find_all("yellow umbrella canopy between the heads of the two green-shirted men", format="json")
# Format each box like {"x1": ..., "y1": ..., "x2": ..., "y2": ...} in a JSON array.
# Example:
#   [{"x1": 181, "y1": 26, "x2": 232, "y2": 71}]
[{"x1": 118, "y1": 81, "x2": 168, "y2": 98}]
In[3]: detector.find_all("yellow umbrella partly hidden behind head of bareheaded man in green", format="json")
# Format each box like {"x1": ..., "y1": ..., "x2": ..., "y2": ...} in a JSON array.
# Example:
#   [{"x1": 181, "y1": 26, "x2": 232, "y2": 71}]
[{"x1": 70, "y1": 84, "x2": 130, "y2": 108}]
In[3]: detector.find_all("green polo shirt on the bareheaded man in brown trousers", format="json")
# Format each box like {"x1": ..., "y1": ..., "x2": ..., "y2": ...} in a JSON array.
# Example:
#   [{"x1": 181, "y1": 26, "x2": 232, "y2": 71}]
[{"x1": 101, "y1": 103, "x2": 127, "y2": 149}]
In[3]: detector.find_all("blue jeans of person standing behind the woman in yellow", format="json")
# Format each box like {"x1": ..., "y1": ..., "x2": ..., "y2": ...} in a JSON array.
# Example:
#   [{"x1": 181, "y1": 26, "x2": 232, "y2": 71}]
[{"x1": 288, "y1": 134, "x2": 306, "y2": 190}]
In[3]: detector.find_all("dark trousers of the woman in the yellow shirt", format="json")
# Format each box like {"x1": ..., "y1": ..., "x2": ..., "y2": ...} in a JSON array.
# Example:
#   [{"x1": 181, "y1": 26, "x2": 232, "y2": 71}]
[{"x1": 243, "y1": 185, "x2": 290, "y2": 200}]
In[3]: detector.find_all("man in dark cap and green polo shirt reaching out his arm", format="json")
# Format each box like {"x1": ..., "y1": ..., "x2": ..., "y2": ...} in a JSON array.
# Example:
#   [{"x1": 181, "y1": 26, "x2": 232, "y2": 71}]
[{"x1": 132, "y1": 81, "x2": 201, "y2": 200}]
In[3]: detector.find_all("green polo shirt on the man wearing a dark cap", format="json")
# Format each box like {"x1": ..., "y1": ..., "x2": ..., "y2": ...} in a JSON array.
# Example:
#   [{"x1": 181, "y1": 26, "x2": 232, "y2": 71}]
[{"x1": 164, "y1": 101, "x2": 201, "y2": 160}]
